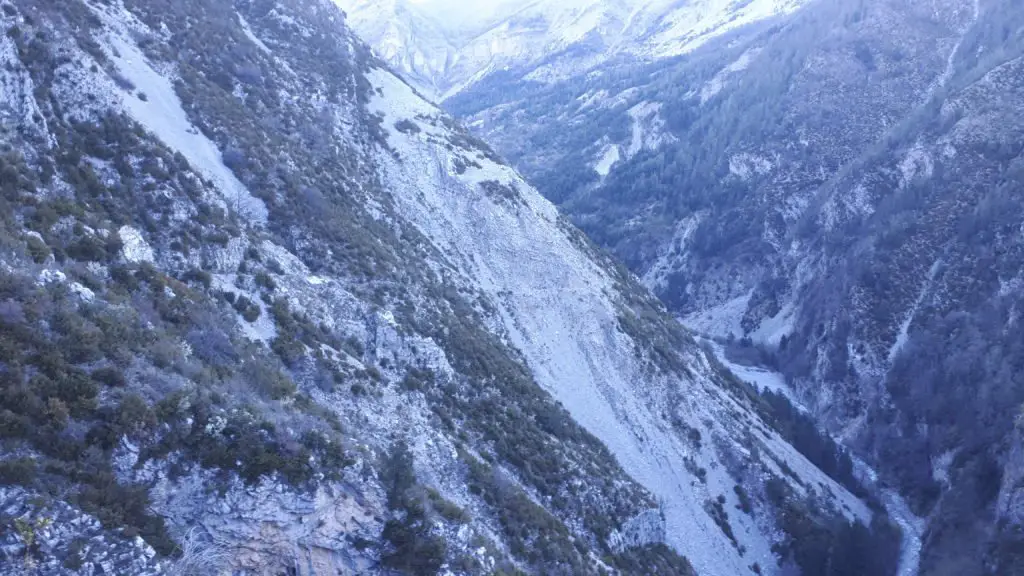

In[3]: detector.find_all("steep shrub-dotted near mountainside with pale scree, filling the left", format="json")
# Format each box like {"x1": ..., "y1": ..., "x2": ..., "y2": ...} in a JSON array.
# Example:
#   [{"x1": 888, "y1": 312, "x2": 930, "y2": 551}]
[{"x1": 0, "y1": 0, "x2": 871, "y2": 575}]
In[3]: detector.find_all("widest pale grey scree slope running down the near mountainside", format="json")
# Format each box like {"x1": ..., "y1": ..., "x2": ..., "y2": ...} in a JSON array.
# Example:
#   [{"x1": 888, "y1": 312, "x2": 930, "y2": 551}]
[{"x1": 369, "y1": 62, "x2": 868, "y2": 576}]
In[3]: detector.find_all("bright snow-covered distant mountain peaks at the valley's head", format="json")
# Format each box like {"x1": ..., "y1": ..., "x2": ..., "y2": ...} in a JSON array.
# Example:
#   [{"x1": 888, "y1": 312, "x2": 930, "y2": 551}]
[{"x1": 335, "y1": 0, "x2": 807, "y2": 99}]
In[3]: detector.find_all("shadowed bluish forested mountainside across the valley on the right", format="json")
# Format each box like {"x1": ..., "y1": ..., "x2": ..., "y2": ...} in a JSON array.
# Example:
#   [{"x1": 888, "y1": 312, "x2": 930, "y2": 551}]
[{"x1": 376, "y1": 0, "x2": 1024, "y2": 574}]
